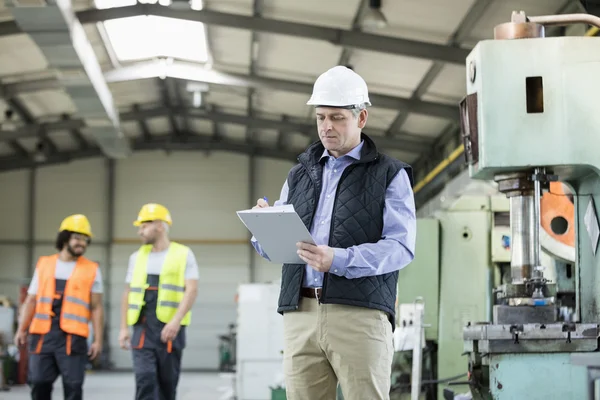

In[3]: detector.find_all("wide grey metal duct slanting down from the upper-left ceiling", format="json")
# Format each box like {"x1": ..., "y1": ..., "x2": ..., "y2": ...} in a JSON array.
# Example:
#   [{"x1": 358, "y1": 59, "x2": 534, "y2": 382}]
[{"x1": 6, "y1": 0, "x2": 131, "y2": 158}]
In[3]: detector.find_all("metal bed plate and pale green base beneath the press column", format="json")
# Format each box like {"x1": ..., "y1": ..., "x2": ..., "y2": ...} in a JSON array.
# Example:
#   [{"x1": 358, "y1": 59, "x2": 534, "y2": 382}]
[{"x1": 463, "y1": 322, "x2": 600, "y2": 400}]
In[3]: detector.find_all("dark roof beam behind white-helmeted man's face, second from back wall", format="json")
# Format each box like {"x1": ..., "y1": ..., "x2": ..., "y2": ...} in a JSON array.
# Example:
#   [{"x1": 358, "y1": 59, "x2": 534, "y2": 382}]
[{"x1": 0, "y1": 106, "x2": 432, "y2": 152}]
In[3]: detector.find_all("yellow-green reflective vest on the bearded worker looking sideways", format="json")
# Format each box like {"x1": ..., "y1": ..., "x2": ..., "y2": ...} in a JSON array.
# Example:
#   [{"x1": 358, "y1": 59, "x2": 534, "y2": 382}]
[{"x1": 127, "y1": 242, "x2": 192, "y2": 326}]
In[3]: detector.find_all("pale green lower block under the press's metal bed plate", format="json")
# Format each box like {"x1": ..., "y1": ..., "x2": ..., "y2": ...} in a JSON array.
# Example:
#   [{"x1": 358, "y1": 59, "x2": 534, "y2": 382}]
[{"x1": 471, "y1": 353, "x2": 588, "y2": 400}]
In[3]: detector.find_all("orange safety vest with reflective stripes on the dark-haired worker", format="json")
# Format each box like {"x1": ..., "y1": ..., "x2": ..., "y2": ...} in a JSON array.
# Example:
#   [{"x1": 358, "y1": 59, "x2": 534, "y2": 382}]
[{"x1": 29, "y1": 254, "x2": 98, "y2": 338}]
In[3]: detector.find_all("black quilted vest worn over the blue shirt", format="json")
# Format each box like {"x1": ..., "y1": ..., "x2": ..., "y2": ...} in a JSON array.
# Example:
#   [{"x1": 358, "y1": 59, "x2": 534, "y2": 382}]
[{"x1": 277, "y1": 134, "x2": 413, "y2": 326}]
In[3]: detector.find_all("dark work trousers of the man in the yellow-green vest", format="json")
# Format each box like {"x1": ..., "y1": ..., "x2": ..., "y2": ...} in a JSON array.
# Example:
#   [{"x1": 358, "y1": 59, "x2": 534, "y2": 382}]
[{"x1": 133, "y1": 346, "x2": 181, "y2": 400}]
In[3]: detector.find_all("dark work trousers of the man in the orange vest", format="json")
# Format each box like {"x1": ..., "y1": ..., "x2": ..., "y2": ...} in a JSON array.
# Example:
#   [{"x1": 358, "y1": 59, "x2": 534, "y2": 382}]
[{"x1": 28, "y1": 350, "x2": 88, "y2": 400}]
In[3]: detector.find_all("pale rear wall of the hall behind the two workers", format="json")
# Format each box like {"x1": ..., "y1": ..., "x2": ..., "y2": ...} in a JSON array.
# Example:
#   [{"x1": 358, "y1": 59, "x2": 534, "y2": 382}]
[{"x1": 0, "y1": 152, "x2": 292, "y2": 368}]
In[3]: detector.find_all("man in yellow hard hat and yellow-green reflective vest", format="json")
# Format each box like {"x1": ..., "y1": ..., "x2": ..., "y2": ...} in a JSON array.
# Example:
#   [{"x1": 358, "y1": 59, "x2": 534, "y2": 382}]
[{"x1": 119, "y1": 203, "x2": 199, "y2": 400}]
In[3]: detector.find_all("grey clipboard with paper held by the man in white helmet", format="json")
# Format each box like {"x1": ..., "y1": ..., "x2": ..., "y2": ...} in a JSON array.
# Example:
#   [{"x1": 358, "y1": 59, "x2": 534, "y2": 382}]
[{"x1": 237, "y1": 204, "x2": 315, "y2": 264}]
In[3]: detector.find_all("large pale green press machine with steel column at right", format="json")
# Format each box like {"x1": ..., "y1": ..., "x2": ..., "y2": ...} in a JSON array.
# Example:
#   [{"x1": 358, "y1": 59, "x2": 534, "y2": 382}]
[{"x1": 460, "y1": 12, "x2": 600, "y2": 400}]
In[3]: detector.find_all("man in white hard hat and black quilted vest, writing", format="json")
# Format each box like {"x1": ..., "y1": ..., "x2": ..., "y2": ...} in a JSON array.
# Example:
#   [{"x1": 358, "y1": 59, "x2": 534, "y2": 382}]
[{"x1": 252, "y1": 66, "x2": 416, "y2": 400}]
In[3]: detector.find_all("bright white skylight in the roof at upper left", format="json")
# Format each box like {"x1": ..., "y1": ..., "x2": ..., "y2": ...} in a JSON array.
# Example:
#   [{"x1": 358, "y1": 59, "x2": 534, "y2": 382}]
[{"x1": 95, "y1": 0, "x2": 208, "y2": 63}]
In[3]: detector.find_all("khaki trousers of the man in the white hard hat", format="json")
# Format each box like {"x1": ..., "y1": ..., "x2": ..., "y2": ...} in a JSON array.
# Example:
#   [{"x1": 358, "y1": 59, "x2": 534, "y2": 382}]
[{"x1": 283, "y1": 298, "x2": 394, "y2": 400}]
